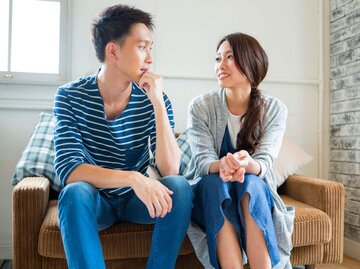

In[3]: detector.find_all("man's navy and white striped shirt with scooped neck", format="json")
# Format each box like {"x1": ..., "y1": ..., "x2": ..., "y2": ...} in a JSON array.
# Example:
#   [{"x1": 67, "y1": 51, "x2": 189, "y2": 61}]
[{"x1": 54, "y1": 75, "x2": 174, "y2": 196}]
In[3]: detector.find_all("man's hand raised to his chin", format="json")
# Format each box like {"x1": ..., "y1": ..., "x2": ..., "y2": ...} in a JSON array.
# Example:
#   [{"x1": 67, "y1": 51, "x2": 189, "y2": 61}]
[{"x1": 139, "y1": 71, "x2": 164, "y2": 106}]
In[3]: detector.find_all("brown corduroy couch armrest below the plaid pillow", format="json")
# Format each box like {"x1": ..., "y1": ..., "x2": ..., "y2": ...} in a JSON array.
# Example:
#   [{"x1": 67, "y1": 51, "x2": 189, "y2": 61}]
[{"x1": 12, "y1": 177, "x2": 50, "y2": 269}]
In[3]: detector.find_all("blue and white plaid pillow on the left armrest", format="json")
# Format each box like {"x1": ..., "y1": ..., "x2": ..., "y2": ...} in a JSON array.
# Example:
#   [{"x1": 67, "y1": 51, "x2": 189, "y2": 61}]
[{"x1": 12, "y1": 112, "x2": 62, "y2": 191}]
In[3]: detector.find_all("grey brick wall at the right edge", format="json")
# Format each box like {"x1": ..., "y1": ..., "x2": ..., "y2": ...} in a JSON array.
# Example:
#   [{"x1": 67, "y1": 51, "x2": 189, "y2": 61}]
[{"x1": 330, "y1": 0, "x2": 360, "y2": 243}]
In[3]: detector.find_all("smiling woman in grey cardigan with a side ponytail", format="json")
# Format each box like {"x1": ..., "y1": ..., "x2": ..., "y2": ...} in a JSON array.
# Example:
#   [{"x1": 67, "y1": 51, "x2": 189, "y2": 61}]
[{"x1": 188, "y1": 33, "x2": 294, "y2": 269}]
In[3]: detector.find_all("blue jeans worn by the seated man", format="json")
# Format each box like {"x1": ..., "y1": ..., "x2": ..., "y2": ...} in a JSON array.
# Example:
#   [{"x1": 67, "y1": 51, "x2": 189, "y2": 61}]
[{"x1": 58, "y1": 176, "x2": 193, "y2": 269}]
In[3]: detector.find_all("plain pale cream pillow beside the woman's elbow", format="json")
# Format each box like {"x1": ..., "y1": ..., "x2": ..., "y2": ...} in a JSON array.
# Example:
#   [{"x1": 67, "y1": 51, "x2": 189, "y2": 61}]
[{"x1": 274, "y1": 137, "x2": 313, "y2": 187}]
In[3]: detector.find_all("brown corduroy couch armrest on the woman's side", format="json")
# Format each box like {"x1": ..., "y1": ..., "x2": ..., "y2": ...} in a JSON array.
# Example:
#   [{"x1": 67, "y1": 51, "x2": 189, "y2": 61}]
[{"x1": 279, "y1": 175, "x2": 345, "y2": 263}]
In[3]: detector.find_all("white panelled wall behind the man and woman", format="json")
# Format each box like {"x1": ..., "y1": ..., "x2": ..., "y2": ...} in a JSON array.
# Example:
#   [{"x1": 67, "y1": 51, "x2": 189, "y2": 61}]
[{"x1": 0, "y1": 0, "x2": 327, "y2": 259}]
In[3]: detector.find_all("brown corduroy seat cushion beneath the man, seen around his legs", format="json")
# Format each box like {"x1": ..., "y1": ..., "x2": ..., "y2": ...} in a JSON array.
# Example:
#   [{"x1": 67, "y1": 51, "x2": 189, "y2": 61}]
[{"x1": 38, "y1": 200, "x2": 194, "y2": 260}]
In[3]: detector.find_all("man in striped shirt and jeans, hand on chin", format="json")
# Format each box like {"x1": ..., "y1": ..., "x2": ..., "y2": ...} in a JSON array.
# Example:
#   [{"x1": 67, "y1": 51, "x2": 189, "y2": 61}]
[{"x1": 54, "y1": 5, "x2": 192, "y2": 269}]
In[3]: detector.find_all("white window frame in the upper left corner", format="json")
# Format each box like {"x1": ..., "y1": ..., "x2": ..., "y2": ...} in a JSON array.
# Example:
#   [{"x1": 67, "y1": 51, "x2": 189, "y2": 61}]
[{"x1": 0, "y1": 0, "x2": 70, "y2": 85}]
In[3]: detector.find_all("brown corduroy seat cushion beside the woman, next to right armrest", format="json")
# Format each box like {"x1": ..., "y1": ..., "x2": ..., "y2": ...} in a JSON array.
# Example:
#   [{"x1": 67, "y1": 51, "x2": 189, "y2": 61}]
[{"x1": 281, "y1": 195, "x2": 331, "y2": 247}]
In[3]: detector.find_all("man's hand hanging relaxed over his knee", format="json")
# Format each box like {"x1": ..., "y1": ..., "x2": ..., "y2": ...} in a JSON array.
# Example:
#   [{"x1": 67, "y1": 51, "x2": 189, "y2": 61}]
[{"x1": 132, "y1": 173, "x2": 173, "y2": 218}]
